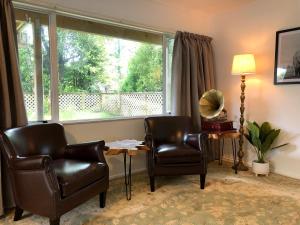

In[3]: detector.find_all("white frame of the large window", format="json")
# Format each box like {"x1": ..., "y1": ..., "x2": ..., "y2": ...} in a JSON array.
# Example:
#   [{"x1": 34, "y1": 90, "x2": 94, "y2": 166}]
[{"x1": 13, "y1": 1, "x2": 175, "y2": 124}]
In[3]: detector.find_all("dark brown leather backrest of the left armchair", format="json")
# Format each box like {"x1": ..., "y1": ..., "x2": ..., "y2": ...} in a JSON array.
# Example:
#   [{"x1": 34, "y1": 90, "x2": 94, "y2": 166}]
[{"x1": 4, "y1": 123, "x2": 67, "y2": 159}]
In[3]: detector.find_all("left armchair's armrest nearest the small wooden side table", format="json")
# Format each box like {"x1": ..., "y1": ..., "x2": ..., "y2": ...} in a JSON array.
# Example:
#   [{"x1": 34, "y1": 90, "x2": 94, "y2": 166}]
[{"x1": 65, "y1": 141, "x2": 106, "y2": 163}]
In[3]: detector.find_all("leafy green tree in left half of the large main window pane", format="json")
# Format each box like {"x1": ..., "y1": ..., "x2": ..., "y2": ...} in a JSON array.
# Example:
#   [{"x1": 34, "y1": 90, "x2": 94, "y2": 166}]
[{"x1": 57, "y1": 28, "x2": 107, "y2": 93}]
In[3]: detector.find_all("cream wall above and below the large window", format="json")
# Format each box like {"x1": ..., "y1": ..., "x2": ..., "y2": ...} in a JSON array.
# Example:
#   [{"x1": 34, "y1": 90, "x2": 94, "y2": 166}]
[{"x1": 16, "y1": 0, "x2": 210, "y2": 177}]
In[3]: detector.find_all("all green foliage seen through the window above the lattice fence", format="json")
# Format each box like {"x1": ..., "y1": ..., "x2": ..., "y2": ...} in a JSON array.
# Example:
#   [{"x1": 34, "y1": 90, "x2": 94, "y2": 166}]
[{"x1": 19, "y1": 26, "x2": 162, "y2": 96}]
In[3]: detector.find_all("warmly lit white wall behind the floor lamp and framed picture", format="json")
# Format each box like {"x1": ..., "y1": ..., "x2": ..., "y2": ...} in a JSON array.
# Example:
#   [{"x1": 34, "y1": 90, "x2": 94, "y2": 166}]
[{"x1": 213, "y1": 0, "x2": 300, "y2": 178}]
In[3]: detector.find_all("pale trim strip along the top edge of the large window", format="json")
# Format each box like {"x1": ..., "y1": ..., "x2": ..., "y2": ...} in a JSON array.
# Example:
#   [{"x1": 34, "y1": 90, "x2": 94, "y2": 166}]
[{"x1": 12, "y1": 1, "x2": 175, "y2": 36}]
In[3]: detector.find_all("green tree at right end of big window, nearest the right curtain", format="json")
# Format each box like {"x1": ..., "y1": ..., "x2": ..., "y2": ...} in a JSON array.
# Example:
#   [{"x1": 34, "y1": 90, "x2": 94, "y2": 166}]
[{"x1": 121, "y1": 44, "x2": 162, "y2": 92}]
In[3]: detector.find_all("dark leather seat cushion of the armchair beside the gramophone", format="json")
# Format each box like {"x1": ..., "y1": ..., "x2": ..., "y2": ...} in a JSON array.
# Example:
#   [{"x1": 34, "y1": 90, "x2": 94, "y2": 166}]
[{"x1": 155, "y1": 144, "x2": 201, "y2": 164}]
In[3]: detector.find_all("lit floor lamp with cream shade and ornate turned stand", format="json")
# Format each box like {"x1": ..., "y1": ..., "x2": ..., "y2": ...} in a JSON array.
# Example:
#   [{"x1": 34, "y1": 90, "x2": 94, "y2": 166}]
[{"x1": 232, "y1": 54, "x2": 256, "y2": 171}]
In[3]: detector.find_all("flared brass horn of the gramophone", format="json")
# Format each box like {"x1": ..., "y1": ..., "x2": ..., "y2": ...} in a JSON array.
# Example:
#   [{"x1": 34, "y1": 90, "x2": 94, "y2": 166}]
[{"x1": 199, "y1": 89, "x2": 224, "y2": 119}]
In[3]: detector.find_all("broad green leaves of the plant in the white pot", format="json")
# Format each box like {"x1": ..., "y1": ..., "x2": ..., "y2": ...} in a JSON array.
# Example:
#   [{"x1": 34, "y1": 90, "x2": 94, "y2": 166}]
[{"x1": 245, "y1": 121, "x2": 280, "y2": 163}]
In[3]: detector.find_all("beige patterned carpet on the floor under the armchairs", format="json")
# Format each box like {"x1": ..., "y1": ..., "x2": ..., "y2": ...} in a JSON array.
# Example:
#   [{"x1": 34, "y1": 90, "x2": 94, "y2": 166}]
[{"x1": 0, "y1": 163, "x2": 300, "y2": 225}]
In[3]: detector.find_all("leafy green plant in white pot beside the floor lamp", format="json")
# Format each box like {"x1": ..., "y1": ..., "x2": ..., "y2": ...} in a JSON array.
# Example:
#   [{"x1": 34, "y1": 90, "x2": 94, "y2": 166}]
[{"x1": 245, "y1": 121, "x2": 280, "y2": 176}]
